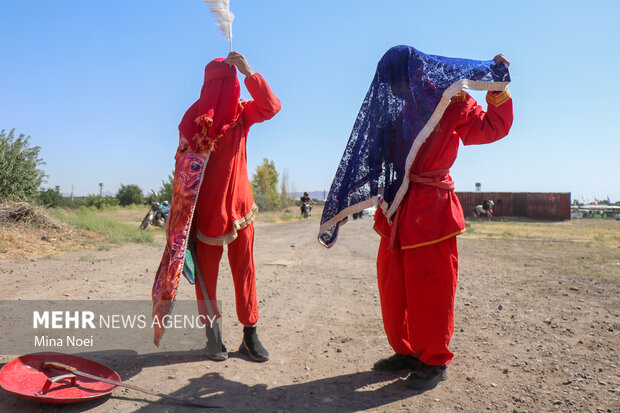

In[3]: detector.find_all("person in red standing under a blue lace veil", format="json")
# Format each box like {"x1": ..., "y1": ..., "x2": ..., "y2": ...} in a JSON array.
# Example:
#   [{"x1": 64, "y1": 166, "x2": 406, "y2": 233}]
[{"x1": 319, "y1": 46, "x2": 513, "y2": 390}]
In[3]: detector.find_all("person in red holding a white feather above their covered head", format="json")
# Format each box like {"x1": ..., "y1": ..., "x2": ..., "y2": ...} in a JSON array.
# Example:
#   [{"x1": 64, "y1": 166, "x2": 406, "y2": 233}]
[{"x1": 153, "y1": 52, "x2": 280, "y2": 362}]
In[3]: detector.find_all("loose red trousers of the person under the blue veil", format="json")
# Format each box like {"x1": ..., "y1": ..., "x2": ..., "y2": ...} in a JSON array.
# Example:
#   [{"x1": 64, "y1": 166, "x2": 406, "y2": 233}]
[{"x1": 377, "y1": 233, "x2": 458, "y2": 365}]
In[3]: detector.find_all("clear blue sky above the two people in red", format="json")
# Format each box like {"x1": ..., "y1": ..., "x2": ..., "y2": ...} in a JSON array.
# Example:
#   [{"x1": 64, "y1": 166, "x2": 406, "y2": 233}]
[{"x1": 0, "y1": 0, "x2": 620, "y2": 201}]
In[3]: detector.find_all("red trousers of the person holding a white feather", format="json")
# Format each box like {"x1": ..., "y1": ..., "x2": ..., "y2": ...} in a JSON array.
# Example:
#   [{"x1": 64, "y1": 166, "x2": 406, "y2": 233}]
[{"x1": 195, "y1": 224, "x2": 258, "y2": 326}]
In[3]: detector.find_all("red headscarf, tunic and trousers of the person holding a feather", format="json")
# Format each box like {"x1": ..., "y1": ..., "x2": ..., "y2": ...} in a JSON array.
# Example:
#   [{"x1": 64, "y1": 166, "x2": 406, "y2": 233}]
[{"x1": 179, "y1": 59, "x2": 280, "y2": 326}]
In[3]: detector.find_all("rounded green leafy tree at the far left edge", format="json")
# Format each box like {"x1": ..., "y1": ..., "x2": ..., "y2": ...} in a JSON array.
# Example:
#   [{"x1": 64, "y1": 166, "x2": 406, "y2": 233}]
[{"x1": 0, "y1": 129, "x2": 46, "y2": 201}]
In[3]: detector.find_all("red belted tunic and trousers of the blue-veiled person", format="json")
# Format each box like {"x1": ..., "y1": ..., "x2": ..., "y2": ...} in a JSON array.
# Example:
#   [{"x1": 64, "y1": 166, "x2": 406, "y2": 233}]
[{"x1": 374, "y1": 89, "x2": 513, "y2": 365}]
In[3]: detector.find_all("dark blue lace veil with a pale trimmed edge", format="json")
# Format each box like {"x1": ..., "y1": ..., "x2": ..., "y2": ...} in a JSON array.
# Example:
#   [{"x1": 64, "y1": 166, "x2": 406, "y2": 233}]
[{"x1": 318, "y1": 46, "x2": 510, "y2": 247}]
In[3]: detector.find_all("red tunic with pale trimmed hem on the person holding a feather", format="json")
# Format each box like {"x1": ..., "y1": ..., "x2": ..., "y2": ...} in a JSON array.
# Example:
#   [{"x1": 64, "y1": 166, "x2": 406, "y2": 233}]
[{"x1": 194, "y1": 73, "x2": 281, "y2": 245}]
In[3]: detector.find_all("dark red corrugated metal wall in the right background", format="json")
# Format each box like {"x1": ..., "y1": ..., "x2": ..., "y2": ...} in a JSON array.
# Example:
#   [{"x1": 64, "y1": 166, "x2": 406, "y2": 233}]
[{"x1": 456, "y1": 192, "x2": 570, "y2": 219}]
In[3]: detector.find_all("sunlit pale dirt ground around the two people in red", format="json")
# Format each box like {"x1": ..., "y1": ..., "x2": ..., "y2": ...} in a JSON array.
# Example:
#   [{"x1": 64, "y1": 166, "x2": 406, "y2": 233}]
[{"x1": 0, "y1": 218, "x2": 620, "y2": 413}]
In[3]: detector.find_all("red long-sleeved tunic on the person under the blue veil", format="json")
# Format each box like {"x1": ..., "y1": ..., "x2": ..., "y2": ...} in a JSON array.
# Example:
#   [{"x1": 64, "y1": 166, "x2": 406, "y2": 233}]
[{"x1": 374, "y1": 89, "x2": 513, "y2": 249}]
